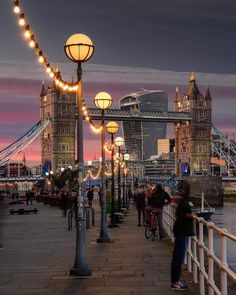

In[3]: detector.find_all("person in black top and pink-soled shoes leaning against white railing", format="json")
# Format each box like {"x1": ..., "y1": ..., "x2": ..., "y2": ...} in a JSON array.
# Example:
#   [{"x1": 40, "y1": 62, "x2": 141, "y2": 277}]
[{"x1": 171, "y1": 183, "x2": 194, "y2": 291}]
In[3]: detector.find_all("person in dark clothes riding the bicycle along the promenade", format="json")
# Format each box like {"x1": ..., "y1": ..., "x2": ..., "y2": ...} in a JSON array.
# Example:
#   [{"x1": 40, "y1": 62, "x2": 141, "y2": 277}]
[{"x1": 148, "y1": 184, "x2": 171, "y2": 240}]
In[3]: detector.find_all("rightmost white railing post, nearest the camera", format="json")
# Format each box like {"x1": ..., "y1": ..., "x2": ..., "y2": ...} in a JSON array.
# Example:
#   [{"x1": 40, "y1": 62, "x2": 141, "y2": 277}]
[{"x1": 220, "y1": 229, "x2": 228, "y2": 295}]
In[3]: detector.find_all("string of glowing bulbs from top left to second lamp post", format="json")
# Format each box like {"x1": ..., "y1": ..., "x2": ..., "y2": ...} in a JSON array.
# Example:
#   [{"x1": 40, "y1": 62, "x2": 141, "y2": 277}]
[{"x1": 13, "y1": 0, "x2": 102, "y2": 133}]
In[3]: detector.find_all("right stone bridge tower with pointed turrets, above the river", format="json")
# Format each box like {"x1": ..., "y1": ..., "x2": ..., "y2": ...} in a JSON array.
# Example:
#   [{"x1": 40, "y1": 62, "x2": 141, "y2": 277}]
[{"x1": 175, "y1": 73, "x2": 212, "y2": 176}]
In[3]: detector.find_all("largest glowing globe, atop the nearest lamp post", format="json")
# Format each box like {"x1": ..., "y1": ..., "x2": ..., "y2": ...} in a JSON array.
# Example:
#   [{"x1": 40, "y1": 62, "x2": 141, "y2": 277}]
[{"x1": 64, "y1": 33, "x2": 94, "y2": 63}]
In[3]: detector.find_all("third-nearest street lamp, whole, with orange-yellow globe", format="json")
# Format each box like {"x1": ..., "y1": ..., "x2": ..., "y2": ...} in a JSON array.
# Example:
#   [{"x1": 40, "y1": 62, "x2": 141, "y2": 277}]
[{"x1": 106, "y1": 121, "x2": 119, "y2": 227}]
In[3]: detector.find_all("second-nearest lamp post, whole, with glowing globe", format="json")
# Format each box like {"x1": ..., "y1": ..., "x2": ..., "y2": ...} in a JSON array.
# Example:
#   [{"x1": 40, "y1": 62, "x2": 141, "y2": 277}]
[{"x1": 94, "y1": 92, "x2": 112, "y2": 243}]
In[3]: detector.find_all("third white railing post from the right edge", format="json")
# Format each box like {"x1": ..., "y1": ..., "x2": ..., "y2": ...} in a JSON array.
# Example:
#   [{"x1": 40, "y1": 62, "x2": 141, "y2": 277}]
[{"x1": 198, "y1": 218, "x2": 205, "y2": 295}]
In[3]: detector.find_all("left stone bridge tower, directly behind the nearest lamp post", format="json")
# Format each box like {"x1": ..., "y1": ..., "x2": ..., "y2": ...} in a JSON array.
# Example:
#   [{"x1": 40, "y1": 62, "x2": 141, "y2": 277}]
[{"x1": 40, "y1": 70, "x2": 76, "y2": 173}]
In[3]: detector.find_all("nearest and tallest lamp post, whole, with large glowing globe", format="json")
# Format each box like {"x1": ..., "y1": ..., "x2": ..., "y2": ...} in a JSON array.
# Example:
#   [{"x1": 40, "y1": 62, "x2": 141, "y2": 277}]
[{"x1": 64, "y1": 34, "x2": 94, "y2": 276}]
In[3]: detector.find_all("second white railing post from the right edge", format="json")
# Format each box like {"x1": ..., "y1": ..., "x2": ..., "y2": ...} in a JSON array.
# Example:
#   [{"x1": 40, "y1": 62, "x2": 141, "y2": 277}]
[{"x1": 207, "y1": 222, "x2": 214, "y2": 295}]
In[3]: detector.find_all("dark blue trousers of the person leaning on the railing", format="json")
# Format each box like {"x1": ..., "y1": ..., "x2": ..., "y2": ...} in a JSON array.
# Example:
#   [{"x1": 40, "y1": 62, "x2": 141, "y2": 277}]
[{"x1": 171, "y1": 236, "x2": 188, "y2": 283}]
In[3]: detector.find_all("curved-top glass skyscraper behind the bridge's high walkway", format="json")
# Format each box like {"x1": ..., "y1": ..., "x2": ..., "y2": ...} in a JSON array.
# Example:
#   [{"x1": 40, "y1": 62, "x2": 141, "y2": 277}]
[{"x1": 120, "y1": 90, "x2": 168, "y2": 161}]
